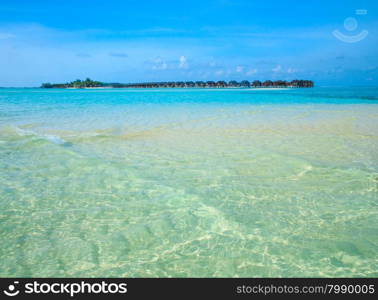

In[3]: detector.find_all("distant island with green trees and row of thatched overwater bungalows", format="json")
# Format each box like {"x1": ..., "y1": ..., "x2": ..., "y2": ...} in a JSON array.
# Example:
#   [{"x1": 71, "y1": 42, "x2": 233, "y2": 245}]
[{"x1": 41, "y1": 78, "x2": 314, "y2": 89}]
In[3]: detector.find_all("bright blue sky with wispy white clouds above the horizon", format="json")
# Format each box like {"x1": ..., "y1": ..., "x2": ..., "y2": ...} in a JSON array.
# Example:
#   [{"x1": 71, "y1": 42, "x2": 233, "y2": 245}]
[{"x1": 0, "y1": 0, "x2": 378, "y2": 86}]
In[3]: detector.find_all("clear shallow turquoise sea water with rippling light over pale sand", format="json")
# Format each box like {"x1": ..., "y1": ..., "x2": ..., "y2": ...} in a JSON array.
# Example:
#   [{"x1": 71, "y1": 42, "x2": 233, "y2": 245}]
[{"x1": 0, "y1": 88, "x2": 378, "y2": 277}]
